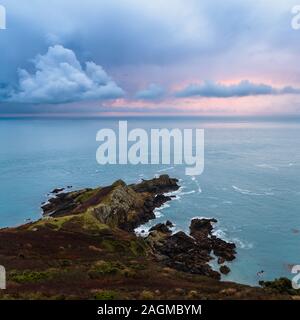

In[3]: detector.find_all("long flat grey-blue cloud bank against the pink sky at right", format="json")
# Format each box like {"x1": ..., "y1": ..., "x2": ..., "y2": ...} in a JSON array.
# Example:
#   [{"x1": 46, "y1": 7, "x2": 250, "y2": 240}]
[{"x1": 176, "y1": 80, "x2": 300, "y2": 98}]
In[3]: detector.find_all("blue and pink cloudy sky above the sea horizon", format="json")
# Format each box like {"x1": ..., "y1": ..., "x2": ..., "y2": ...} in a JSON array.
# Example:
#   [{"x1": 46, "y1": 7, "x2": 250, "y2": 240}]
[{"x1": 0, "y1": 0, "x2": 300, "y2": 116}]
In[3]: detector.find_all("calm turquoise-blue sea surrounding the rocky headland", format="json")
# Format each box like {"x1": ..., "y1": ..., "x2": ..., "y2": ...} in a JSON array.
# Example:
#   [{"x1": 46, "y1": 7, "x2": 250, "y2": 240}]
[{"x1": 0, "y1": 118, "x2": 300, "y2": 284}]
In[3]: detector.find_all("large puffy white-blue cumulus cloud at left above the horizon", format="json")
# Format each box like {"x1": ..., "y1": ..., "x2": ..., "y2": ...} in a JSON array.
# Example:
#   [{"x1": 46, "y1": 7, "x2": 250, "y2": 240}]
[{"x1": 8, "y1": 45, "x2": 124, "y2": 104}]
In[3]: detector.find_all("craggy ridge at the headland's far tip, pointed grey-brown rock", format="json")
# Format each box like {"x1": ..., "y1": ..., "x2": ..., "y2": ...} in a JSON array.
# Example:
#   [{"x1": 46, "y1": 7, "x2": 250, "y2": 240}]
[{"x1": 42, "y1": 175, "x2": 179, "y2": 231}]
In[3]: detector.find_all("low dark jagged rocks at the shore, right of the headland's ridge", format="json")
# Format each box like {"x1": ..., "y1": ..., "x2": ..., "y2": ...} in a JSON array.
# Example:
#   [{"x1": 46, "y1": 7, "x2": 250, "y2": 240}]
[{"x1": 147, "y1": 219, "x2": 236, "y2": 279}]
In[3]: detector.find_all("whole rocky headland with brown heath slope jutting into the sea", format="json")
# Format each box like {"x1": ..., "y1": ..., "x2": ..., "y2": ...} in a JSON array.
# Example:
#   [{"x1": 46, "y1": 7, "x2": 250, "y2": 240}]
[{"x1": 0, "y1": 175, "x2": 295, "y2": 299}]
